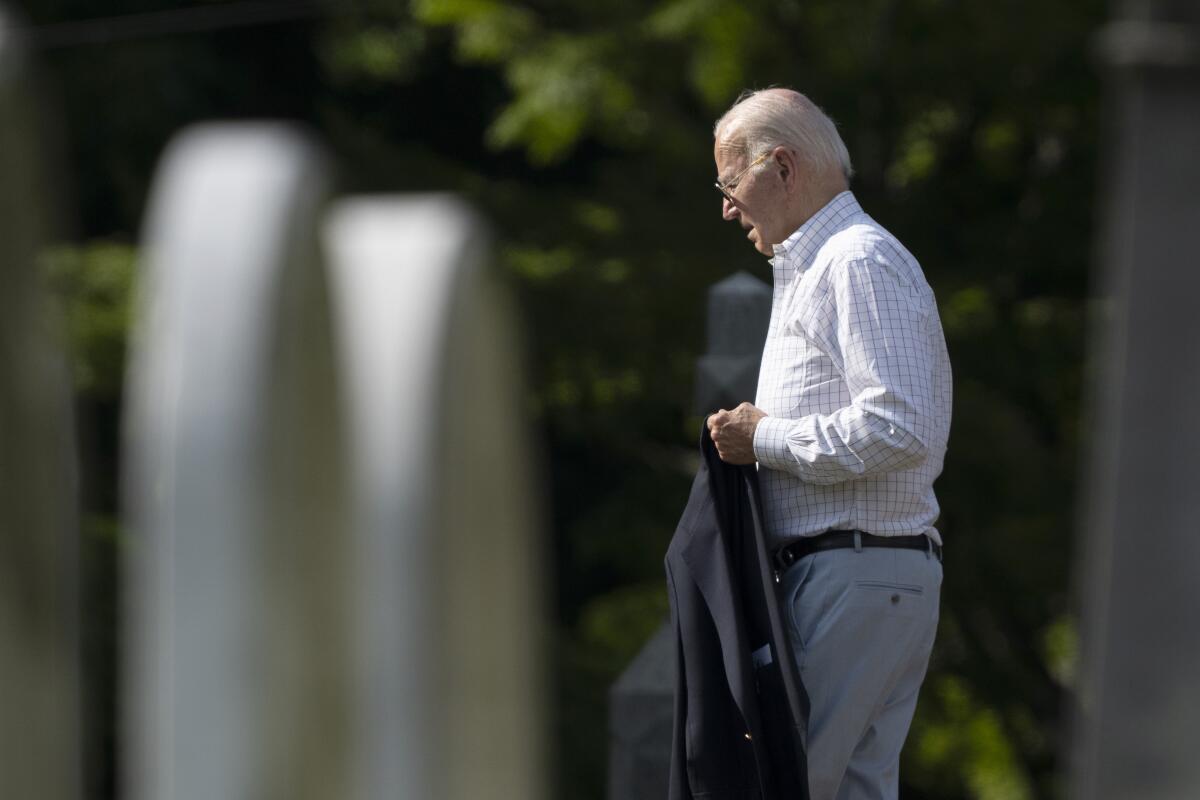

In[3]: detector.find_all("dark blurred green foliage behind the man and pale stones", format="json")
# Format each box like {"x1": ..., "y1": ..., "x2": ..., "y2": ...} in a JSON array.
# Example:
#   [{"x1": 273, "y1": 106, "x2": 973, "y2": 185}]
[{"x1": 16, "y1": 0, "x2": 1105, "y2": 800}]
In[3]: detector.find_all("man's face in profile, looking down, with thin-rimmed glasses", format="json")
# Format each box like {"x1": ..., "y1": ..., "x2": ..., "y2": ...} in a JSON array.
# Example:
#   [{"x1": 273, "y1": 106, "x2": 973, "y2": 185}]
[{"x1": 713, "y1": 142, "x2": 792, "y2": 255}]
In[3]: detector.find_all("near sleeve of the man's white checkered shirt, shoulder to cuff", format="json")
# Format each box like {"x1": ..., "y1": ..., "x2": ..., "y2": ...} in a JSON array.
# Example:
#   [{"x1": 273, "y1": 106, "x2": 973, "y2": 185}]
[{"x1": 754, "y1": 258, "x2": 936, "y2": 483}]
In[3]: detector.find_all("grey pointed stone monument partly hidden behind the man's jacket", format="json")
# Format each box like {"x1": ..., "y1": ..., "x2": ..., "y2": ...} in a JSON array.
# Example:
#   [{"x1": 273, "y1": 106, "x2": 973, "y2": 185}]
[{"x1": 608, "y1": 272, "x2": 770, "y2": 800}]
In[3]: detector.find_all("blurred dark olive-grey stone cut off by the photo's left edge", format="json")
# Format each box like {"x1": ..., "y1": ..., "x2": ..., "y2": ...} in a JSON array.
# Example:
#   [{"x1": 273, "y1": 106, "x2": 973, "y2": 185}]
[{"x1": 0, "y1": 6, "x2": 80, "y2": 800}]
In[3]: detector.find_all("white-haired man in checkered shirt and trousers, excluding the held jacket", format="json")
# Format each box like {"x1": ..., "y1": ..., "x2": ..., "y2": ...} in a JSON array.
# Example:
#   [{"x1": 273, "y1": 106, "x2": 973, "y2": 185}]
[{"x1": 708, "y1": 89, "x2": 950, "y2": 800}]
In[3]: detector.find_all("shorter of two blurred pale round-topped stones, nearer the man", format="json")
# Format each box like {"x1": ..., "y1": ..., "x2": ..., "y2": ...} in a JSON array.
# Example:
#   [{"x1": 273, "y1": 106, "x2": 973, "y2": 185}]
[{"x1": 324, "y1": 196, "x2": 547, "y2": 800}]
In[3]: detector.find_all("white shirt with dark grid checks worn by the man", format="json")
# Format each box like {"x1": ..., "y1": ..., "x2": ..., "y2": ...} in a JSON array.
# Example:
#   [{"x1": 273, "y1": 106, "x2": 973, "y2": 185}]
[{"x1": 754, "y1": 192, "x2": 950, "y2": 543}]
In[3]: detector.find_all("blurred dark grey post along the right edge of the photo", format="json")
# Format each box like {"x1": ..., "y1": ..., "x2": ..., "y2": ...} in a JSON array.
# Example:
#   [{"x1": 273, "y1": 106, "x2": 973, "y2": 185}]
[{"x1": 1075, "y1": 0, "x2": 1200, "y2": 800}]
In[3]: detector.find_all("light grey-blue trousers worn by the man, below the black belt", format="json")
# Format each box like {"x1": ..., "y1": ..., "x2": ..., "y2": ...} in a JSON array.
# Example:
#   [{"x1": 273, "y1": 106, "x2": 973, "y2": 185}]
[{"x1": 781, "y1": 547, "x2": 942, "y2": 800}]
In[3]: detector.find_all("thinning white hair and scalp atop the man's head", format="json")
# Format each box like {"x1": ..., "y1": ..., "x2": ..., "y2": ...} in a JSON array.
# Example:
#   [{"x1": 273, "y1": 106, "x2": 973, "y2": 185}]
[{"x1": 713, "y1": 89, "x2": 854, "y2": 181}]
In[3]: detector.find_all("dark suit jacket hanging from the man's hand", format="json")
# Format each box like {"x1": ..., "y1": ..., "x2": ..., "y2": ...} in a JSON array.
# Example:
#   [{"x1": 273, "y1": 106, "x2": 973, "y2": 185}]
[{"x1": 666, "y1": 426, "x2": 808, "y2": 800}]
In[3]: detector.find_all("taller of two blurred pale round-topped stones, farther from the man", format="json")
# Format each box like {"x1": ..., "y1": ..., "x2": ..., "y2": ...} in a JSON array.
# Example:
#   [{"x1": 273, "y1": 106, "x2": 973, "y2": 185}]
[{"x1": 125, "y1": 125, "x2": 353, "y2": 800}]
